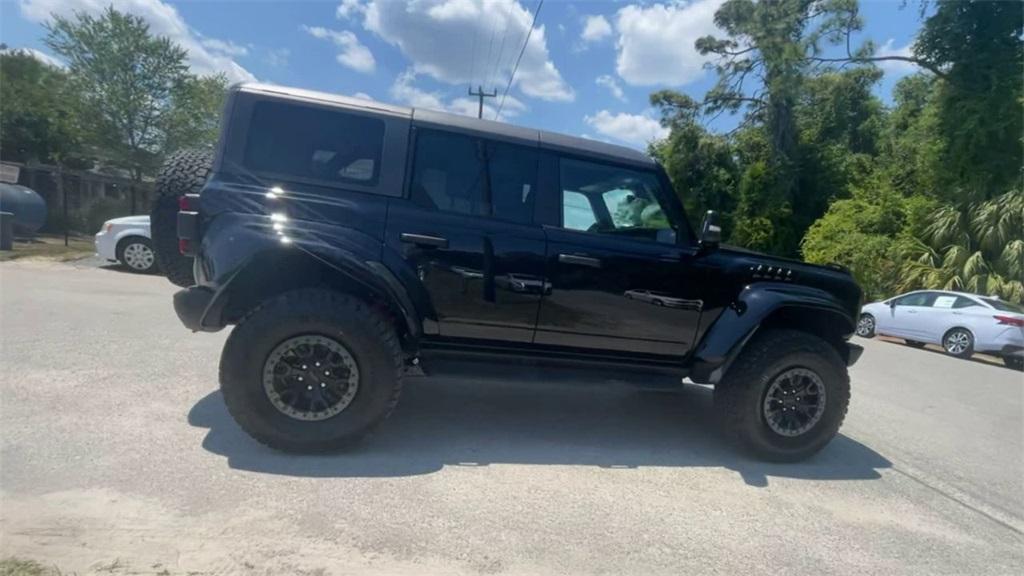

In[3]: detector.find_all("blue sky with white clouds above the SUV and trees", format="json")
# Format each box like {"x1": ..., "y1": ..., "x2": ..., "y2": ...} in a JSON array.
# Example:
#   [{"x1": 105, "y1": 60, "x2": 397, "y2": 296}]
[{"x1": 0, "y1": 0, "x2": 921, "y2": 148}]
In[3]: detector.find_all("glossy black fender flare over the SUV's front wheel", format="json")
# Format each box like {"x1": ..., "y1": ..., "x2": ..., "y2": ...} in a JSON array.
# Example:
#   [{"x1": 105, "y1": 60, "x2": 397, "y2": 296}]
[{"x1": 690, "y1": 283, "x2": 856, "y2": 383}]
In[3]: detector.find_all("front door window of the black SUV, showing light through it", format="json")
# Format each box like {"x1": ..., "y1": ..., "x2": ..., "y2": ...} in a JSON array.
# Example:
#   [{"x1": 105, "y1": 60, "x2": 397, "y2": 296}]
[{"x1": 559, "y1": 159, "x2": 674, "y2": 243}]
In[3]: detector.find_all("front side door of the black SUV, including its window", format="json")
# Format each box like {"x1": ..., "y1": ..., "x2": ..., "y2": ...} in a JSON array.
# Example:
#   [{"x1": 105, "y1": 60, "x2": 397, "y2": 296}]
[{"x1": 535, "y1": 156, "x2": 702, "y2": 358}]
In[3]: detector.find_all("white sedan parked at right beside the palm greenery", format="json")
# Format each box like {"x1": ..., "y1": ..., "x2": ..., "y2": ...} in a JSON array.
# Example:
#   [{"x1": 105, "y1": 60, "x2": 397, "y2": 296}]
[{"x1": 857, "y1": 290, "x2": 1024, "y2": 369}]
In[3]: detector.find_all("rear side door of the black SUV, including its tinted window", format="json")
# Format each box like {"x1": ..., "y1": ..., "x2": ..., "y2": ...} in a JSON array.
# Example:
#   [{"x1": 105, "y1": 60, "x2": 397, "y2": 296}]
[{"x1": 385, "y1": 127, "x2": 548, "y2": 342}]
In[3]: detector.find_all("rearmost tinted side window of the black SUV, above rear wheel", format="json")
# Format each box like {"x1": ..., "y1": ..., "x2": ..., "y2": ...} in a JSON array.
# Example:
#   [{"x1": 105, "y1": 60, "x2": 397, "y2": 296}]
[{"x1": 243, "y1": 101, "x2": 384, "y2": 186}]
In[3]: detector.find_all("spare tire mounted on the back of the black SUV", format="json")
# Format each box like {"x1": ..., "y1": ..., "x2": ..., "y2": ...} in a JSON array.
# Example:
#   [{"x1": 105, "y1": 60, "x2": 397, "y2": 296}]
[{"x1": 150, "y1": 150, "x2": 213, "y2": 288}]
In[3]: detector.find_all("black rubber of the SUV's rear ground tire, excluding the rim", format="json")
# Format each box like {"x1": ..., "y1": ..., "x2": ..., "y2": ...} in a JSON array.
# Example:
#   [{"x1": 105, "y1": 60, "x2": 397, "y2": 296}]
[{"x1": 220, "y1": 289, "x2": 402, "y2": 453}]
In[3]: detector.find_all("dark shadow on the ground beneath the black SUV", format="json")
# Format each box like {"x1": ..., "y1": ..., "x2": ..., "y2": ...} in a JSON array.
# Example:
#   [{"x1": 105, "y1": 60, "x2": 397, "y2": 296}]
[{"x1": 188, "y1": 370, "x2": 891, "y2": 487}]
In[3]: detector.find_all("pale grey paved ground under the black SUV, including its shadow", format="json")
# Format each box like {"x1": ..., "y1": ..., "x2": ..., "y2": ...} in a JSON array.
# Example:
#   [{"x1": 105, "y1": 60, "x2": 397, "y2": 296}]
[{"x1": 0, "y1": 262, "x2": 1024, "y2": 576}]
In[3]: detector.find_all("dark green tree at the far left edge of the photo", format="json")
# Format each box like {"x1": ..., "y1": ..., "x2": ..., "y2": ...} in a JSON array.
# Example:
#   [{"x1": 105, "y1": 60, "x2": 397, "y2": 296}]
[{"x1": 0, "y1": 50, "x2": 89, "y2": 168}]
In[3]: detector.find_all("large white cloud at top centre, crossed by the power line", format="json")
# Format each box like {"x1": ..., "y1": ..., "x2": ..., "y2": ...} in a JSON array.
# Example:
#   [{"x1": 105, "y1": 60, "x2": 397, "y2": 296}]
[{"x1": 350, "y1": 0, "x2": 575, "y2": 101}]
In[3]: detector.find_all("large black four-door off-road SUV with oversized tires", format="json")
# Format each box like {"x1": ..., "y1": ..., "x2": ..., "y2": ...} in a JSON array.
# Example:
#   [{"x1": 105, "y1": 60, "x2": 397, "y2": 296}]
[{"x1": 153, "y1": 84, "x2": 861, "y2": 460}]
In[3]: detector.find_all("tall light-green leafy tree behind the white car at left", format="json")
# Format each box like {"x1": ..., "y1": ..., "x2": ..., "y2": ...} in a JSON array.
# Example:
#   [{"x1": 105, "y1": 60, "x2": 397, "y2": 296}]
[{"x1": 45, "y1": 7, "x2": 225, "y2": 179}]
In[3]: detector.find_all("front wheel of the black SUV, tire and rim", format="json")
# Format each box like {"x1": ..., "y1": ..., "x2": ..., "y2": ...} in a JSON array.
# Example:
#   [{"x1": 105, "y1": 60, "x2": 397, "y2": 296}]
[{"x1": 715, "y1": 330, "x2": 850, "y2": 462}]
